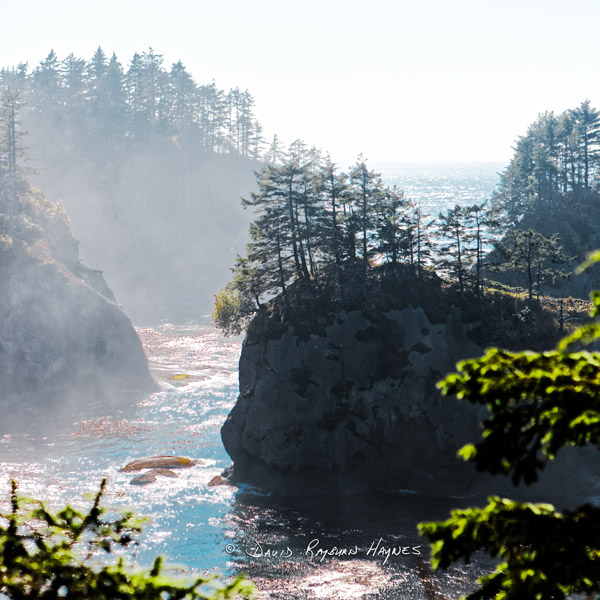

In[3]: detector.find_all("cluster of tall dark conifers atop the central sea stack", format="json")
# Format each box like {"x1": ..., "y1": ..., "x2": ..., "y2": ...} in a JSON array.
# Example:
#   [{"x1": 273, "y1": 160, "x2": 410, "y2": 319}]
[{"x1": 214, "y1": 145, "x2": 448, "y2": 333}]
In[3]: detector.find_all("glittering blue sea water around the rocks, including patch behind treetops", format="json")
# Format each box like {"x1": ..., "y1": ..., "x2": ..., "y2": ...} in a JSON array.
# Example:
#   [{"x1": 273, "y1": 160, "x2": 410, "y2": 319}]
[{"x1": 0, "y1": 162, "x2": 506, "y2": 600}]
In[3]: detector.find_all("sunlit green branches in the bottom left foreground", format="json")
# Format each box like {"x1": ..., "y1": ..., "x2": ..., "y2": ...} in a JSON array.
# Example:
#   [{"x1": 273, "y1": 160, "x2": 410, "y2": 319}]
[{"x1": 0, "y1": 480, "x2": 253, "y2": 600}]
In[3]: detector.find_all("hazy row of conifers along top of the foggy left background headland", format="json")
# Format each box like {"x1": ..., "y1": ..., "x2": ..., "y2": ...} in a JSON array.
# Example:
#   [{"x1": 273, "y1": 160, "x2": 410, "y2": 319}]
[{"x1": 0, "y1": 47, "x2": 263, "y2": 159}]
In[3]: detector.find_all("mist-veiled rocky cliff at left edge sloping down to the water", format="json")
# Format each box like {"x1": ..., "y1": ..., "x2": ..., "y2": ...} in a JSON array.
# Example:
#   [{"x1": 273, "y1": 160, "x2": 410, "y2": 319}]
[{"x1": 0, "y1": 181, "x2": 154, "y2": 406}]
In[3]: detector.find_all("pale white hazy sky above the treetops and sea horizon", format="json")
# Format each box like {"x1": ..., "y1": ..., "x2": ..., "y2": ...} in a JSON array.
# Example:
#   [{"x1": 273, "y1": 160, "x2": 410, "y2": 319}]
[{"x1": 0, "y1": 0, "x2": 600, "y2": 162}]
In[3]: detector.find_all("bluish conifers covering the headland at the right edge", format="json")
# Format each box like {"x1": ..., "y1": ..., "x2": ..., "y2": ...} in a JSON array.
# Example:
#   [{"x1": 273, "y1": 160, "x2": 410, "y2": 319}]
[{"x1": 494, "y1": 100, "x2": 600, "y2": 260}]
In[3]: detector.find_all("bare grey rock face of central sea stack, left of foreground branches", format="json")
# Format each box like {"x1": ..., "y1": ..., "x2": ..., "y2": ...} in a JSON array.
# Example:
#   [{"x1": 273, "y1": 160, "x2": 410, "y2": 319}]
[{"x1": 222, "y1": 306, "x2": 488, "y2": 493}]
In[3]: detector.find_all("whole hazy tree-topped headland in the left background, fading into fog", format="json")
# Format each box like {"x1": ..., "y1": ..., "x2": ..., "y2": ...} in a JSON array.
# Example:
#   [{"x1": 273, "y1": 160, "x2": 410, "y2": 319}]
[{"x1": 0, "y1": 48, "x2": 268, "y2": 322}]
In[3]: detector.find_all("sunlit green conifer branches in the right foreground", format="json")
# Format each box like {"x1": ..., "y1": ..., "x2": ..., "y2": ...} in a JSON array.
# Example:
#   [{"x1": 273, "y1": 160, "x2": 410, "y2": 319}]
[{"x1": 419, "y1": 252, "x2": 600, "y2": 600}]
